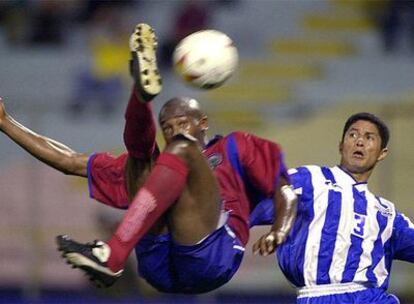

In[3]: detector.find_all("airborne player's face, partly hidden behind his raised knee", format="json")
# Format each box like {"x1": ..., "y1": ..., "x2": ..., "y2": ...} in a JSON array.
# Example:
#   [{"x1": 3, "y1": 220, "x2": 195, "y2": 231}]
[{"x1": 161, "y1": 115, "x2": 204, "y2": 144}]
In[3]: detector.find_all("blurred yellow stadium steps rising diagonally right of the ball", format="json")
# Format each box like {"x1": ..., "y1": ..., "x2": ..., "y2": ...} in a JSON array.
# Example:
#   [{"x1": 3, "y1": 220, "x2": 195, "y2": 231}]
[{"x1": 201, "y1": 1, "x2": 372, "y2": 127}]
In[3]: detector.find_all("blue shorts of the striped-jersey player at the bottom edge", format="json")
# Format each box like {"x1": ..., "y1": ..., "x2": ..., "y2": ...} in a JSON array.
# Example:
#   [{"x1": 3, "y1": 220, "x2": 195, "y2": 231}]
[{"x1": 296, "y1": 288, "x2": 400, "y2": 304}]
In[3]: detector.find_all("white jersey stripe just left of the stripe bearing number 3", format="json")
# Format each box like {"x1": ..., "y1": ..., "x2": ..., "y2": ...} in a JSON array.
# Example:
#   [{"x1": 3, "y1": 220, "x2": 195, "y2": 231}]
[{"x1": 303, "y1": 166, "x2": 328, "y2": 286}]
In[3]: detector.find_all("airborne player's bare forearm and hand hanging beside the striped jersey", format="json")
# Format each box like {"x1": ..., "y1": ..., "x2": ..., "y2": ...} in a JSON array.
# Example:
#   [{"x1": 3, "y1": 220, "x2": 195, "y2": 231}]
[{"x1": 253, "y1": 177, "x2": 297, "y2": 256}]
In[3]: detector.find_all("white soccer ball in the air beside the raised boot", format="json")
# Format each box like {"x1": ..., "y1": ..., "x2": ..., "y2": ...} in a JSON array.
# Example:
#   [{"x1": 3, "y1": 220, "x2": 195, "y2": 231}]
[{"x1": 173, "y1": 30, "x2": 239, "y2": 89}]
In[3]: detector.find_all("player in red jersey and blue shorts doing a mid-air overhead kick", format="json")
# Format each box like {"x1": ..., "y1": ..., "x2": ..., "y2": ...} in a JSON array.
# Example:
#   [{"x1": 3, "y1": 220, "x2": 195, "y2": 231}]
[{"x1": 0, "y1": 24, "x2": 296, "y2": 293}]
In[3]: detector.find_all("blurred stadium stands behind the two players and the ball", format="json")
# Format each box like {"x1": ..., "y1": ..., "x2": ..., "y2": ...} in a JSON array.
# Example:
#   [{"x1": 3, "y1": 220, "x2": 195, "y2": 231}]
[{"x1": 0, "y1": 0, "x2": 414, "y2": 303}]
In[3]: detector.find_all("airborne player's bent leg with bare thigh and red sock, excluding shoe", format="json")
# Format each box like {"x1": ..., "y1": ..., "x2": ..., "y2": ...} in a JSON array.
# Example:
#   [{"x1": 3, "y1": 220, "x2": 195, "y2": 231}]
[{"x1": 108, "y1": 139, "x2": 220, "y2": 270}]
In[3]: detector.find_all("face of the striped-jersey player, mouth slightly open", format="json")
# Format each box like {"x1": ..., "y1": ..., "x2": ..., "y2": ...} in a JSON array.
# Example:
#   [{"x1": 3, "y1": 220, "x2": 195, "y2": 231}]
[{"x1": 339, "y1": 120, "x2": 387, "y2": 181}]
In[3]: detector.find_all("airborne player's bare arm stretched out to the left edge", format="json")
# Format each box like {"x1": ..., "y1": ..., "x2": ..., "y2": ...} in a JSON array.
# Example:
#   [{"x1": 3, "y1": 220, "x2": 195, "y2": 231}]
[{"x1": 0, "y1": 98, "x2": 89, "y2": 177}]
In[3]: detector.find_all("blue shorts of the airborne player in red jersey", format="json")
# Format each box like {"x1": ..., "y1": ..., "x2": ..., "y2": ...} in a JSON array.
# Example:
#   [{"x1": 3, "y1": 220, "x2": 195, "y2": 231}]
[{"x1": 135, "y1": 225, "x2": 244, "y2": 293}]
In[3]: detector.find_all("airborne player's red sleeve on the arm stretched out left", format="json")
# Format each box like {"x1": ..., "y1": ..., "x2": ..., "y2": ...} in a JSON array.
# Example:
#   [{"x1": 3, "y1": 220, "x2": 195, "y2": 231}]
[{"x1": 88, "y1": 153, "x2": 129, "y2": 209}]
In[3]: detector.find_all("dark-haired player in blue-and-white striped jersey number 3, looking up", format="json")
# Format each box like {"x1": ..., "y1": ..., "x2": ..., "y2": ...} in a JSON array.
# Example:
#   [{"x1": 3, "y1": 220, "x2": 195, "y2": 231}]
[{"x1": 255, "y1": 113, "x2": 414, "y2": 304}]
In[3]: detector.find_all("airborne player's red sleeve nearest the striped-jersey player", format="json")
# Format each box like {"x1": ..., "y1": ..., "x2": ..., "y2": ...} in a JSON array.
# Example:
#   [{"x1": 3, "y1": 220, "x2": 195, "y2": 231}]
[{"x1": 234, "y1": 132, "x2": 288, "y2": 197}]
